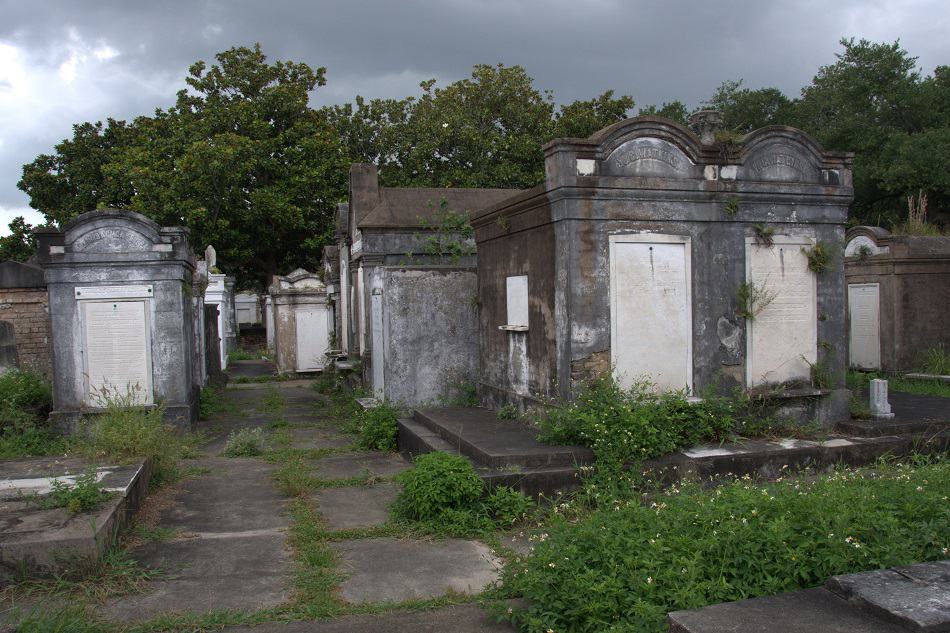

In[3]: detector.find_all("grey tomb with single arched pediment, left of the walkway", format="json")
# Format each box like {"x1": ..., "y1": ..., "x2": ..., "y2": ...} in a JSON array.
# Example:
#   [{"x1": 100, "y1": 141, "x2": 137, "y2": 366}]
[{"x1": 37, "y1": 210, "x2": 200, "y2": 428}]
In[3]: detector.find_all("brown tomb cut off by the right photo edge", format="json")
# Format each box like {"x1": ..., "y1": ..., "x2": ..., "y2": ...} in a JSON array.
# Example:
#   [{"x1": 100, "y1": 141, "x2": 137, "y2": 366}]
[{"x1": 845, "y1": 226, "x2": 950, "y2": 372}]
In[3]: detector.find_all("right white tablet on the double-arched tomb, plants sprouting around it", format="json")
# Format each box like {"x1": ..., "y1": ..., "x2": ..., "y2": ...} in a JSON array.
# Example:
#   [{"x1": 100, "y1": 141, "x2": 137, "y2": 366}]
[{"x1": 746, "y1": 236, "x2": 818, "y2": 387}]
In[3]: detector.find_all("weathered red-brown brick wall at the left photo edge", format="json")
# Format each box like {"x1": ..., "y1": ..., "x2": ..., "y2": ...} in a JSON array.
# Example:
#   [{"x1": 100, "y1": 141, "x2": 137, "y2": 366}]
[{"x1": 0, "y1": 288, "x2": 52, "y2": 378}]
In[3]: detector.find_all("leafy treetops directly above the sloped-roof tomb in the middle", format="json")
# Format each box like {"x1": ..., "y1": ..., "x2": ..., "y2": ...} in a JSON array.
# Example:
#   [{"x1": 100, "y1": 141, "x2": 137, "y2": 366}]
[{"x1": 324, "y1": 64, "x2": 633, "y2": 188}]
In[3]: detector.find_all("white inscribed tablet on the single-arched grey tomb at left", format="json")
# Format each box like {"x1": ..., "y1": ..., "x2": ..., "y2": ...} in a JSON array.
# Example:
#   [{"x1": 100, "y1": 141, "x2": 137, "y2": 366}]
[{"x1": 81, "y1": 301, "x2": 152, "y2": 407}]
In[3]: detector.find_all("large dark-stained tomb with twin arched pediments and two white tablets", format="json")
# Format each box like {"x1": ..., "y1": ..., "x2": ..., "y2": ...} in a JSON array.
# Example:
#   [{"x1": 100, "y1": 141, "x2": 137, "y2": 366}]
[{"x1": 473, "y1": 112, "x2": 853, "y2": 422}]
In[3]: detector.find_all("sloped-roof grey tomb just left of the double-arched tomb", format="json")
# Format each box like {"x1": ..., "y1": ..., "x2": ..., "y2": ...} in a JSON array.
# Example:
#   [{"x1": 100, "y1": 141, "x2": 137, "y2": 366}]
[{"x1": 337, "y1": 164, "x2": 518, "y2": 405}]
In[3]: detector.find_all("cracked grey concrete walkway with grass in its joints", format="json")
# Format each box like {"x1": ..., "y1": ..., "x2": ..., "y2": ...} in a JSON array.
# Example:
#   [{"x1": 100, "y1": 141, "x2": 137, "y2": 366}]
[{"x1": 98, "y1": 381, "x2": 512, "y2": 633}]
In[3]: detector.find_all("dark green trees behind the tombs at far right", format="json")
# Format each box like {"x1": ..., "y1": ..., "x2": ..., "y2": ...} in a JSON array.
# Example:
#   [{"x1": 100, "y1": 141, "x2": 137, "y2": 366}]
[{"x1": 704, "y1": 39, "x2": 950, "y2": 227}]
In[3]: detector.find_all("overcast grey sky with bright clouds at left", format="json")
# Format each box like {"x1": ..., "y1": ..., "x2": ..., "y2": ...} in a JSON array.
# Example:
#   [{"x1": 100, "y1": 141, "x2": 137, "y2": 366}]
[{"x1": 0, "y1": 0, "x2": 950, "y2": 233}]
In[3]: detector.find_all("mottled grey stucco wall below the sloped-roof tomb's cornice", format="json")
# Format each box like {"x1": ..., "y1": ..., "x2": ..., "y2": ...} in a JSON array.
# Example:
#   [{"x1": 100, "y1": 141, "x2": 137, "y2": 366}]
[{"x1": 380, "y1": 266, "x2": 478, "y2": 405}]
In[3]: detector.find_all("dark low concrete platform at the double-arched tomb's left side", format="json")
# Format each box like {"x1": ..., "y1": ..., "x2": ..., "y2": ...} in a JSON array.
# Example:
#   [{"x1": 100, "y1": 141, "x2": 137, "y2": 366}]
[{"x1": 413, "y1": 407, "x2": 594, "y2": 469}]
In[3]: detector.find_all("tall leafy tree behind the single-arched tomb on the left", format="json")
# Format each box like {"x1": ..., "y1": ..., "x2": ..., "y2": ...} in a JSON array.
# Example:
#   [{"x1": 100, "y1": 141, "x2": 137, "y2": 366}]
[{"x1": 20, "y1": 45, "x2": 347, "y2": 284}]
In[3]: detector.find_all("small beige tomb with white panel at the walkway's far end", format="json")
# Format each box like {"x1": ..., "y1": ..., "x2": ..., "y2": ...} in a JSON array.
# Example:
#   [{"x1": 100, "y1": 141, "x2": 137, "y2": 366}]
[{"x1": 270, "y1": 268, "x2": 330, "y2": 373}]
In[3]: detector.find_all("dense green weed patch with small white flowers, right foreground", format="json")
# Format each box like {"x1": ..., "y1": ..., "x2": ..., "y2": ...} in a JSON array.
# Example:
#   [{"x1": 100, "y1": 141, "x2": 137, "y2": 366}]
[{"x1": 503, "y1": 460, "x2": 950, "y2": 633}]
